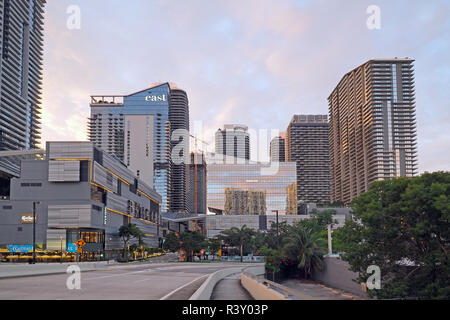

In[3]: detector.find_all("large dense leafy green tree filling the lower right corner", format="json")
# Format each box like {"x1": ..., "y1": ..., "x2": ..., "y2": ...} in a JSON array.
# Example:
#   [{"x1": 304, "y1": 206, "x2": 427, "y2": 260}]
[{"x1": 334, "y1": 172, "x2": 450, "y2": 299}]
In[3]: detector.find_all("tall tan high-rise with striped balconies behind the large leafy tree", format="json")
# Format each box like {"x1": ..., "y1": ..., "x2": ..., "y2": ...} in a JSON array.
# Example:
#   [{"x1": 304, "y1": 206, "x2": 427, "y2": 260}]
[{"x1": 328, "y1": 58, "x2": 417, "y2": 203}]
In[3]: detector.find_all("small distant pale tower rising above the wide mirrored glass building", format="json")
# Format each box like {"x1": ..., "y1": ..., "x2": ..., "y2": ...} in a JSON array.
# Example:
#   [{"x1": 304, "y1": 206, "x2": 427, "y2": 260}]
[{"x1": 216, "y1": 124, "x2": 250, "y2": 160}]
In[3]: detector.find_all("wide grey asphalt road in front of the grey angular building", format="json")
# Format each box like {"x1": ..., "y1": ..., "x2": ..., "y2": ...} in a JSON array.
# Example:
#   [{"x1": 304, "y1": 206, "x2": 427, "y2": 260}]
[{"x1": 0, "y1": 263, "x2": 250, "y2": 300}]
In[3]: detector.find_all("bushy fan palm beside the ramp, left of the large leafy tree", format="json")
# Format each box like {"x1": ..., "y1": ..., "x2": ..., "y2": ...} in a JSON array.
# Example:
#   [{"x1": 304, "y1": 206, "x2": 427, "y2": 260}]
[{"x1": 283, "y1": 226, "x2": 324, "y2": 279}]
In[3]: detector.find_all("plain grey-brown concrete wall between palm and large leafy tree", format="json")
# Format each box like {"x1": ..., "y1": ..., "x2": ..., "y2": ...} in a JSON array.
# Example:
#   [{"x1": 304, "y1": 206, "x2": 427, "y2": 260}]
[{"x1": 313, "y1": 257, "x2": 368, "y2": 298}]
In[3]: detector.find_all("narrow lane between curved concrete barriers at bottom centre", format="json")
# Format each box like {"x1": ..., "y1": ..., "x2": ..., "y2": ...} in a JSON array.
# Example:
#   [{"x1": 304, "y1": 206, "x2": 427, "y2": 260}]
[{"x1": 211, "y1": 273, "x2": 253, "y2": 300}]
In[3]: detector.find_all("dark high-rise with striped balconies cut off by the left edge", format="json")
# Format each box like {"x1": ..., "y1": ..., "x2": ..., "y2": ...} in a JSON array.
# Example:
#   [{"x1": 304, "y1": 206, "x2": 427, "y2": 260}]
[{"x1": 0, "y1": 0, "x2": 46, "y2": 190}]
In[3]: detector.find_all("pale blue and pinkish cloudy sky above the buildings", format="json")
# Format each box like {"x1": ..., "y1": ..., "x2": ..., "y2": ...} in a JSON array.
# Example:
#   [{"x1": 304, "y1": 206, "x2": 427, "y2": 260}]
[{"x1": 42, "y1": 0, "x2": 450, "y2": 172}]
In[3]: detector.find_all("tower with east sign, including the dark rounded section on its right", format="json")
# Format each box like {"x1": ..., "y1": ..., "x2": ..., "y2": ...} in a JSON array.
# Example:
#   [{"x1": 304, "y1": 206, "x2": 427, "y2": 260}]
[{"x1": 88, "y1": 83, "x2": 189, "y2": 213}]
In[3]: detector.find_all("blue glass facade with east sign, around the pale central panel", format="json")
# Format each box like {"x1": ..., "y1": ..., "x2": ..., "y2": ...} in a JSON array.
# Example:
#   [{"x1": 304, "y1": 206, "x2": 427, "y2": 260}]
[{"x1": 89, "y1": 83, "x2": 171, "y2": 212}]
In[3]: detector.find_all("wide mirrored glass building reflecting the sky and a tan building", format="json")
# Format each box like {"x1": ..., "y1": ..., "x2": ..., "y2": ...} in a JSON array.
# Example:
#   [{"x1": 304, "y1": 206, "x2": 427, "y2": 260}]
[{"x1": 207, "y1": 154, "x2": 297, "y2": 215}]
